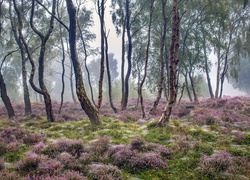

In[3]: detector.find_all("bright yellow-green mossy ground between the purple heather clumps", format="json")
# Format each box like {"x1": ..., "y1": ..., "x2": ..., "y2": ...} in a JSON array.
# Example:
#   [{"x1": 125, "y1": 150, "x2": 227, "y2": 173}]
[{"x1": 0, "y1": 97, "x2": 250, "y2": 180}]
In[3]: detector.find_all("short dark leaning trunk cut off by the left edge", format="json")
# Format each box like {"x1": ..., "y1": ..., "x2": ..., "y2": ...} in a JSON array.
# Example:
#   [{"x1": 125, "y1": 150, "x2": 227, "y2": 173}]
[{"x1": 0, "y1": 71, "x2": 15, "y2": 119}]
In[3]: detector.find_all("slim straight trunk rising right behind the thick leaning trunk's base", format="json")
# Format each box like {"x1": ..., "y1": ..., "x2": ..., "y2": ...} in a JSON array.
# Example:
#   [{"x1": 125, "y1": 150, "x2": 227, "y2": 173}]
[{"x1": 97, "y1": 0, "x2": 105, "y2": 112}]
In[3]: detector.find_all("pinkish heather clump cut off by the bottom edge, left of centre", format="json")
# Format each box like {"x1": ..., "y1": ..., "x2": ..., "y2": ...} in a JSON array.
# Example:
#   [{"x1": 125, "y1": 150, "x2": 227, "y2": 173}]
[{"x1": 88, "y1": 164, "x2": 123, "y2": 180}]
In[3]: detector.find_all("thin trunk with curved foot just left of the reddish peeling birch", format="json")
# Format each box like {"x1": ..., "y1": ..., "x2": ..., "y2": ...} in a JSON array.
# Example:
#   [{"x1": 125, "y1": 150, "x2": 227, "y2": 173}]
[{"x1": 149, "y1": 0, "x2": 167, "y2": 114}]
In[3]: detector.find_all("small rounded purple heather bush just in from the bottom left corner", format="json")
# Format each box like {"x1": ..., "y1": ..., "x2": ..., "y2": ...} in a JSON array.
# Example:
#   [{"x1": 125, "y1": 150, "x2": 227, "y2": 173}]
[{"x1": 14, "y1": 153, "x2": 41, "y2": 173}]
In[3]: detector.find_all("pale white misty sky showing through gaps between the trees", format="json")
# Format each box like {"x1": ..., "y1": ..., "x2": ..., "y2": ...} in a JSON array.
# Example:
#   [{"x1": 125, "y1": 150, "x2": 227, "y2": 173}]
[{"x1": 86, "y1": 0, "x2": 246, "y2": 96}]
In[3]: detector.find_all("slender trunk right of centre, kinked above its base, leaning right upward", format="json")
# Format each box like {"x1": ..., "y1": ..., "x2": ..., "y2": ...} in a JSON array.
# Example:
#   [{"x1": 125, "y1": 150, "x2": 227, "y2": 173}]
[{"x1": 139, "y1": 0, "x2": 154, "y2": 118}]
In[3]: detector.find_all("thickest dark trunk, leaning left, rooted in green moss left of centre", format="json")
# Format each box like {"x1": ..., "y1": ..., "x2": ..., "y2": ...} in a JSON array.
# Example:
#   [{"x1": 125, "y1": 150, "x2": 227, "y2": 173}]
[{"x1": 66, "y1": 0, "x2": 101, "y2": 126}]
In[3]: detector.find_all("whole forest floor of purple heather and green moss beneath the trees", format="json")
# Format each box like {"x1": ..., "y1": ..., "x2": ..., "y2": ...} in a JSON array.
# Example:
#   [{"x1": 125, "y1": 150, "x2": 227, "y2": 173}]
[{"x1": 0, "y1": 97, "x2": 250, "y2": 180}]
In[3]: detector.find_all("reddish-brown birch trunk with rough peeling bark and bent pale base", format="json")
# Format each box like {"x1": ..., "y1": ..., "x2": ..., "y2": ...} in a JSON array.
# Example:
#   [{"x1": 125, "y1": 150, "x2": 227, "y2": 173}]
[{"x1": 157, "y1": 0, "x2": 180, "y2": 126}]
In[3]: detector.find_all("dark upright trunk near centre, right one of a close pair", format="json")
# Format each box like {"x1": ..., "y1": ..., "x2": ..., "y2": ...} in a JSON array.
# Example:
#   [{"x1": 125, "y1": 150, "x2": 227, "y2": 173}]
[{"x1": 122, "y1": 0, "x2": 132, "y2": 110}]
